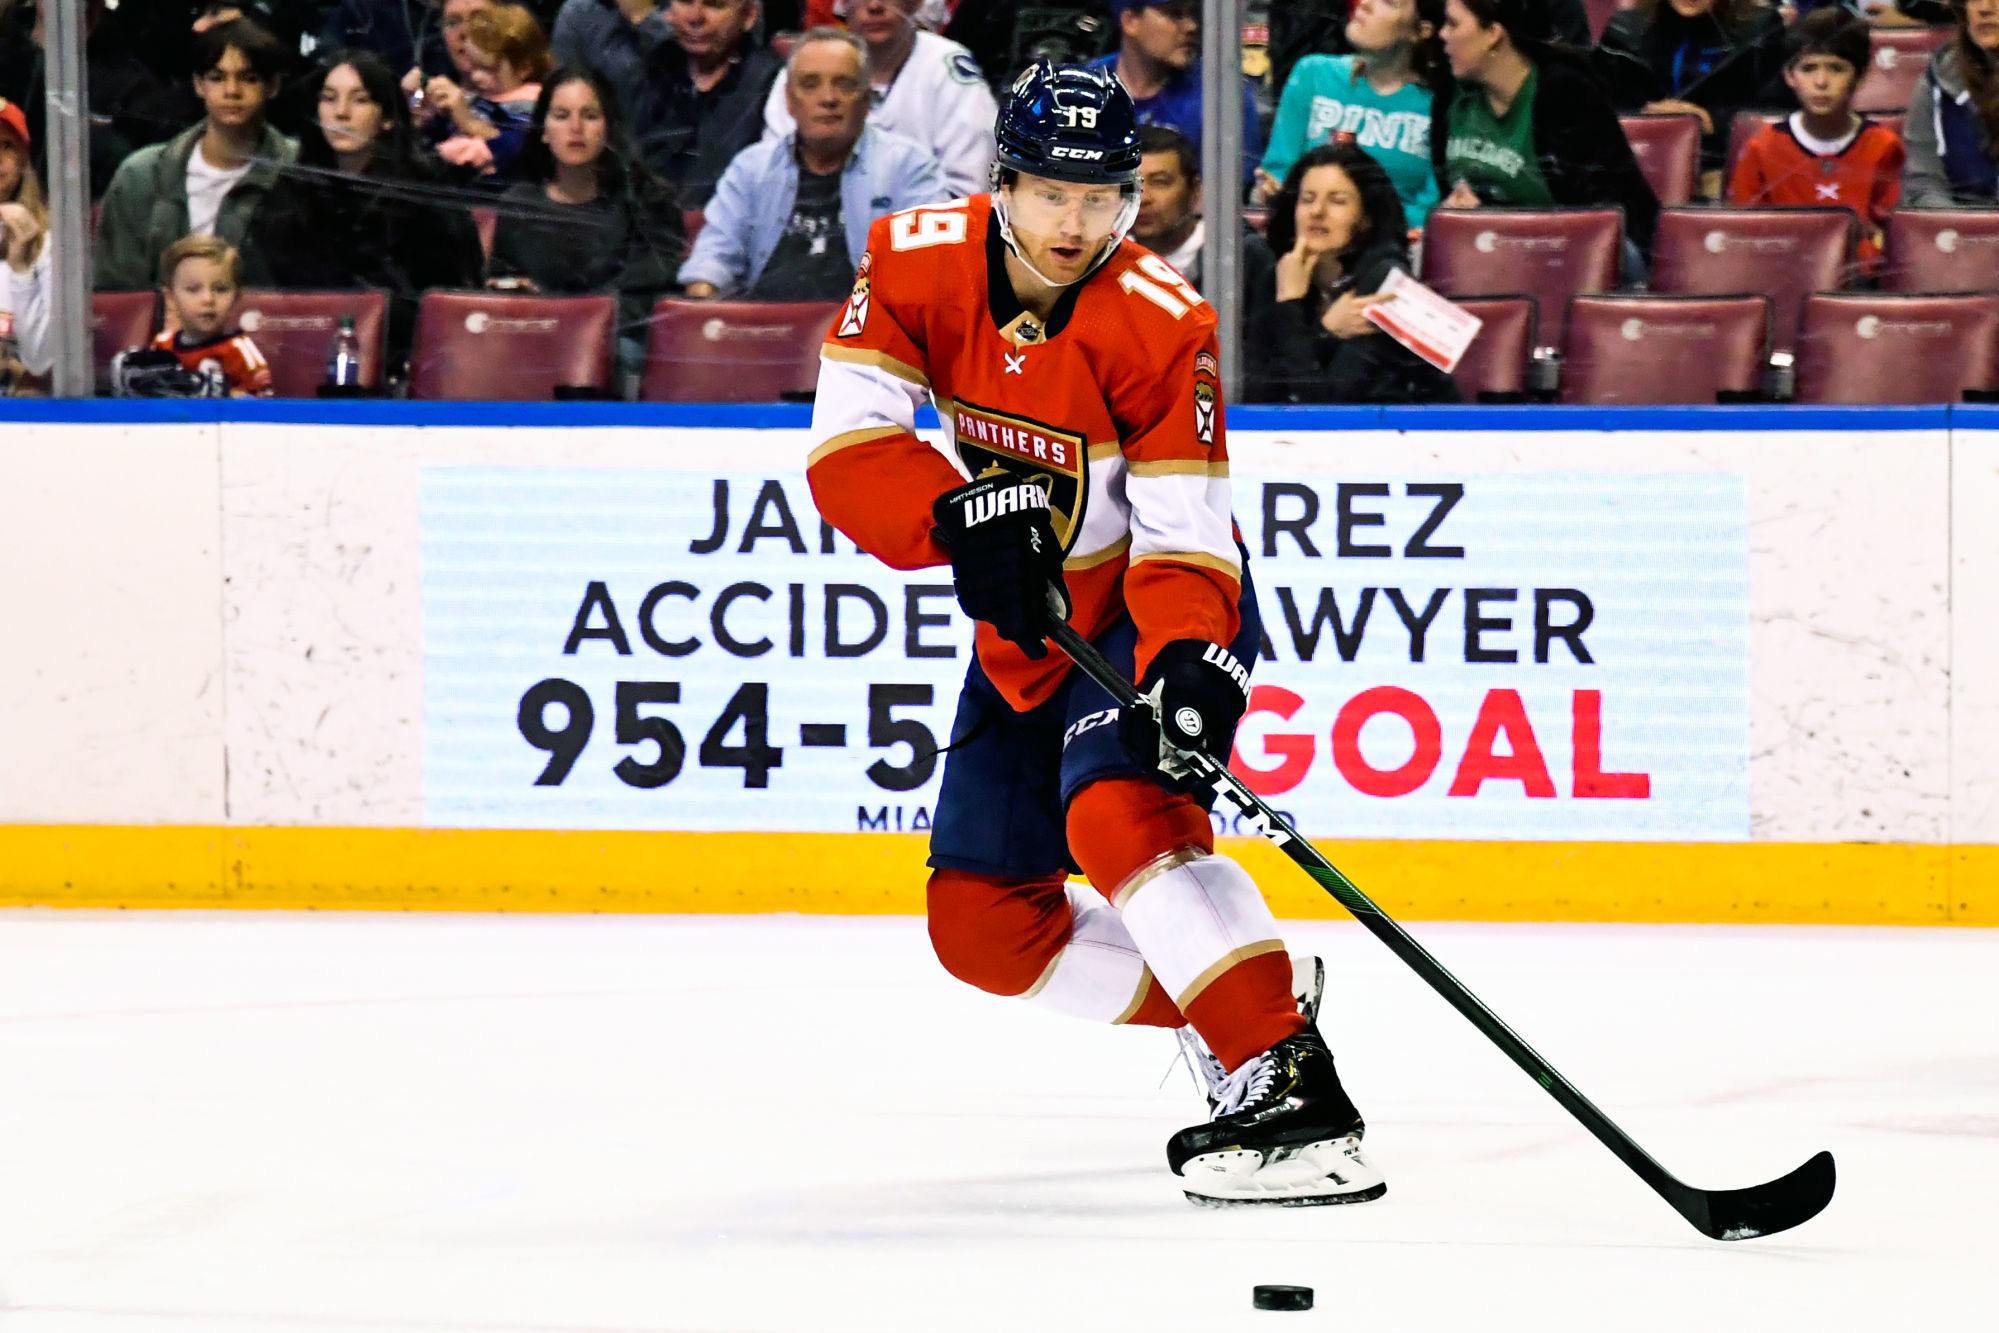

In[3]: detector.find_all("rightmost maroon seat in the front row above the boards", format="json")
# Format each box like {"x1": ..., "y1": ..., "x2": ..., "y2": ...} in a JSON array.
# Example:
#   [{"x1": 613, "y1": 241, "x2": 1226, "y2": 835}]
[{"x1": 1797, "y1": 292, "x2": 1999, "y2": 404}]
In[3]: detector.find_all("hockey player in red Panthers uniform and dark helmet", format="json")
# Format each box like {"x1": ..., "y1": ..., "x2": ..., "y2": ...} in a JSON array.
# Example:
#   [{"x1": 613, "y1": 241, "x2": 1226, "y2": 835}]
[{"x1": 810, "y1": 62, "x2": 1385, "y2": 1205}]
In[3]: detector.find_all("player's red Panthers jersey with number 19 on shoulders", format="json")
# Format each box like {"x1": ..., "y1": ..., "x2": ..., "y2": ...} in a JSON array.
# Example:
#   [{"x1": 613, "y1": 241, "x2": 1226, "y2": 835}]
[{"x1": 808, "y1": 194, "x2": 1241, "y2": 707}]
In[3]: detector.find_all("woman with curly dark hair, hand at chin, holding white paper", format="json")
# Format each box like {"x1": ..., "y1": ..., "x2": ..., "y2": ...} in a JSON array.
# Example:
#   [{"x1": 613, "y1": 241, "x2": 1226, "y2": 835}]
[{"x1": 1243, "y1": 142, "x2": 1461, "y2": 404}]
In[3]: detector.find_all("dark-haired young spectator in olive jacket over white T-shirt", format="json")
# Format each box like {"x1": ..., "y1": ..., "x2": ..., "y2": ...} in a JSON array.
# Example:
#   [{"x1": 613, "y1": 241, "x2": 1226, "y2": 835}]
[{"x1": 94, "y1": 18, "x2": 298, "y2": 292}]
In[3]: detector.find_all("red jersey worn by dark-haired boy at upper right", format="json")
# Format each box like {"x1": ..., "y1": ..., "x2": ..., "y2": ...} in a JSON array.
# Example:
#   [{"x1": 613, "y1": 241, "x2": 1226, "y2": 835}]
[{"x1": 1729, "y1": 114, "x2": 1907, "y2": 272}]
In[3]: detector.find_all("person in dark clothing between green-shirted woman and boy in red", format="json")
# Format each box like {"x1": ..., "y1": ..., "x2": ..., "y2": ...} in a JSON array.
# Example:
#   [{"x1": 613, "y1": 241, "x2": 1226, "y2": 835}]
[{"x1": 1597, "y1": 0, "x2": 1783, "y2": 172}]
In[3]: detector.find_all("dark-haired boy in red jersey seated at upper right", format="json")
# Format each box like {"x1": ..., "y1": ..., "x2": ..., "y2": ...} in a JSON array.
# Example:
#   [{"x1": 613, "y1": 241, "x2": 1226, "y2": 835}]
[{"x1": 1729, "y1": 6, "x2": 1903, "y2": 274}]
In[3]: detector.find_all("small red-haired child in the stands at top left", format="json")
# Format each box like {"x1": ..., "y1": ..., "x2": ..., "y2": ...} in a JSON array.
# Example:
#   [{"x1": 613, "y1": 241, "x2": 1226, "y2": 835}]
[{"x1": 426, "y1": 4, "x2": 554, "y2": 176}]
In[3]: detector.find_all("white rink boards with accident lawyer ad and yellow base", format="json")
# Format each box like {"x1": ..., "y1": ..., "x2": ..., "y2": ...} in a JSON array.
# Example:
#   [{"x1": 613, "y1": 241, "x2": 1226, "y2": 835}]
[{"x1": 0, "y1": 404, "x2": 1999, "y2": 923}]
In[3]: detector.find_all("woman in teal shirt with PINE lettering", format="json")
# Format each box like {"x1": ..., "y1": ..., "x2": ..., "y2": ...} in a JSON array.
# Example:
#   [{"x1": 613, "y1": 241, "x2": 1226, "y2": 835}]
[{"x1": 1257, "y1": 0, "x2": 1443, "y2": 226}]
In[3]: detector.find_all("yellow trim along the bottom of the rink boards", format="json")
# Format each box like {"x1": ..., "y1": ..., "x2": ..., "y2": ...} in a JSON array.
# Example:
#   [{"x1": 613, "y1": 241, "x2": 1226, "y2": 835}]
[{"x1": 0, "y1": 823, "x2": 1999, "y2": 925}]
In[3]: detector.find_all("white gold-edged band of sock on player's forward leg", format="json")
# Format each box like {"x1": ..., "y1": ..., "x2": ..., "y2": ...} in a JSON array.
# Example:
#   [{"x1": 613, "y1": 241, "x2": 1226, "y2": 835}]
[{"x1": 1111, "y1": 847, "x2": 1283, "y2": 1013}]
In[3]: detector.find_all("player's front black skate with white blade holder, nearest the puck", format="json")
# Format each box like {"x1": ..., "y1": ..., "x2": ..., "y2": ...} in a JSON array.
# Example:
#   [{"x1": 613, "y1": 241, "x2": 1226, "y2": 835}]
[{"x1": 1165, "y1": 1029, "x2": 1387, "y2": 1207}]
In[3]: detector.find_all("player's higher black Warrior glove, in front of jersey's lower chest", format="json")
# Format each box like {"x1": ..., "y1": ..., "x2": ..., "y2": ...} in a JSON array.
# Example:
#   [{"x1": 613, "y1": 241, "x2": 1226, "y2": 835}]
[{"x1": 930, "y1": 474, "x2": 1069, "y2": 660}]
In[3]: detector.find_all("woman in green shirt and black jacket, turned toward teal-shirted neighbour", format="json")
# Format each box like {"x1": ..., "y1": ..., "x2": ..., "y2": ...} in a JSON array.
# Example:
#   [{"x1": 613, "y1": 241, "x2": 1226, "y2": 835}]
[{"x1": 1429, "y1": 0, "x2": 1659, "y2": 252}]
